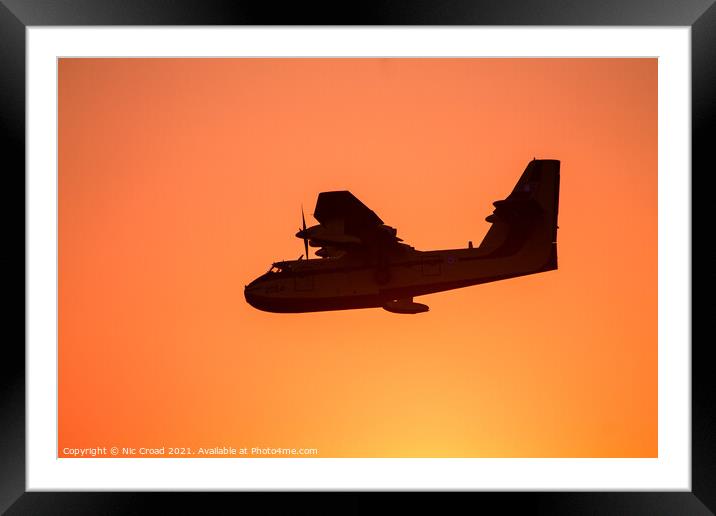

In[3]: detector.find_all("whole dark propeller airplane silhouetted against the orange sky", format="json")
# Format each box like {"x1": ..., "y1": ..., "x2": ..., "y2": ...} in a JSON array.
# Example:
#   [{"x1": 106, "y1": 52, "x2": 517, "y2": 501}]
[{"x1": 244, "y1": 159, "x2": 560, "y2": 314}]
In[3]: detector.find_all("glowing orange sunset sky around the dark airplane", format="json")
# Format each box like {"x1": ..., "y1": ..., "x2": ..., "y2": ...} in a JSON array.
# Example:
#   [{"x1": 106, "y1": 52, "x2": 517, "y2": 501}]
[{"x1": 58, "y1": 59, "x2": 657, "y2": 457}]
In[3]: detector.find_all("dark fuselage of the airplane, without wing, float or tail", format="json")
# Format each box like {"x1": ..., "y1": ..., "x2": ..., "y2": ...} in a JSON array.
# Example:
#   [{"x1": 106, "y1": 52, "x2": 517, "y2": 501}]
[{"x1": 245, "y1": 240, "x2": 557, "y2": 313}]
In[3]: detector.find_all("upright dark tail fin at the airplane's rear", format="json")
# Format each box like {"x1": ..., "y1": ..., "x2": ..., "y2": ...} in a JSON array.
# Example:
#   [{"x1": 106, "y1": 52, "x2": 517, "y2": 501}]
[{"x1": 479, "y1": 159, "x2": 560, "y2": 272}]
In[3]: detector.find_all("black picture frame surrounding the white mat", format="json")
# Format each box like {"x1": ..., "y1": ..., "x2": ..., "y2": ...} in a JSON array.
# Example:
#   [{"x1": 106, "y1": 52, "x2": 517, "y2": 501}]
[{"x1": 0, "y1": 0, "x2": 716, "y2": 515}]
